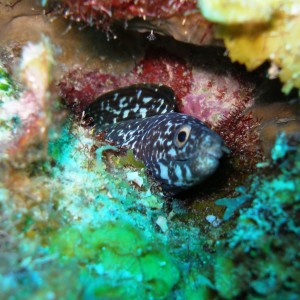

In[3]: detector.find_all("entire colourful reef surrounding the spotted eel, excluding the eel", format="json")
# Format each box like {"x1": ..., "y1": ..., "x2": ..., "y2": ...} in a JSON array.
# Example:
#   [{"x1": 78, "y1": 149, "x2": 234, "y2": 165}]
[{"x1": 0, "y1": 0, "x2": 300, "y2": 300}]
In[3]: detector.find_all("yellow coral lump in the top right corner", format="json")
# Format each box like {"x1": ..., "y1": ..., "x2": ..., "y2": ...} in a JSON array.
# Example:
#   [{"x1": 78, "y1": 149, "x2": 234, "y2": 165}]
[{"x1": 199, "y1": 0, "x2": 300, "y2": 93}]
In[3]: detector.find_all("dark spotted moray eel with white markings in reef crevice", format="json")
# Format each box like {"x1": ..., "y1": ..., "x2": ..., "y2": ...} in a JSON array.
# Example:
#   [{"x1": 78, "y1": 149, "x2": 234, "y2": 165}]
[{"x1": 85, "y1": 84, "x2": 227, "y2": 194}]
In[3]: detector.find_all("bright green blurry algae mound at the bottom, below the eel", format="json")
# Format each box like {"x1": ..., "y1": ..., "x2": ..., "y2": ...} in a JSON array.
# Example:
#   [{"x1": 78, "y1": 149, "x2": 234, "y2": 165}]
[{"x1": 49, "y1": 222, "x2": 179, "y2": 299}]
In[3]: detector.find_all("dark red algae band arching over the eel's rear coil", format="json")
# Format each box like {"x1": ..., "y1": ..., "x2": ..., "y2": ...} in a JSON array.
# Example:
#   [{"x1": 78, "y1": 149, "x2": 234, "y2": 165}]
[{"x1": 59, "y1": 50, "x2": 192, "y2": 116}]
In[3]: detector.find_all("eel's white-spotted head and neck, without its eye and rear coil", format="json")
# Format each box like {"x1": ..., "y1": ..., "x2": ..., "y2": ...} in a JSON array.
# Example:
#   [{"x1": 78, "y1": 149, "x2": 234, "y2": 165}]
[{"x1": 105, "y1": 112, "x2": 223, "y2": 193}]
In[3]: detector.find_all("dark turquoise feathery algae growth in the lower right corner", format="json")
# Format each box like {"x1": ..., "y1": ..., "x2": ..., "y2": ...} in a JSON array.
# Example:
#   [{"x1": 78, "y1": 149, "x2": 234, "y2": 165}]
[{"x1": 214, "y1": 134, "x2": 300, "y2": 299}]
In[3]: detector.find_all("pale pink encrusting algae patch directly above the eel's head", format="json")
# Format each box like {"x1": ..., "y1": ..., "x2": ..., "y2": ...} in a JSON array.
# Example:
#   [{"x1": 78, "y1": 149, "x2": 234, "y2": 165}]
[{"x1": 182, "y1": 68, "x2": 254, "y2": 126}]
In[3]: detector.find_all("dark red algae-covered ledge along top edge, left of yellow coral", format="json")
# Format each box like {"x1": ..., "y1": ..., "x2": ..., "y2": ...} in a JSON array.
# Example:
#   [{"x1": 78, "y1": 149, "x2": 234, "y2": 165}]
[{"x1": 55, "y1": 0, "x2": 216, "y2": 45}]
